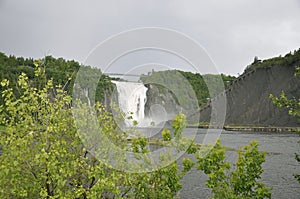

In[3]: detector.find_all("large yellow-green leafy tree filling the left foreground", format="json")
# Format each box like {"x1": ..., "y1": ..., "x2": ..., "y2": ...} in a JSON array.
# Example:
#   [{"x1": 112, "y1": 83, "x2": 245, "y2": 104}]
[{"x1": 0, "y1": 70, "x2": 119, "y2": 198}]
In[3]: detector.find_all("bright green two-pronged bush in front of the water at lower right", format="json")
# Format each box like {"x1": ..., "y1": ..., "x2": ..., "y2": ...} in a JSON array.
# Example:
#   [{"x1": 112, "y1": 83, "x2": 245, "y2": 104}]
[{"x1": 196, "y1": 140, "x2": 271, "y2": 199}]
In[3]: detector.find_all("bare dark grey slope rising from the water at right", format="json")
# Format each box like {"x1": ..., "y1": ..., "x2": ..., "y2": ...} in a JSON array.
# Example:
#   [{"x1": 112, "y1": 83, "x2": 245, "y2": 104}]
[{"x1": 200, "y1": 66, "x2": 300, "y2": 126}]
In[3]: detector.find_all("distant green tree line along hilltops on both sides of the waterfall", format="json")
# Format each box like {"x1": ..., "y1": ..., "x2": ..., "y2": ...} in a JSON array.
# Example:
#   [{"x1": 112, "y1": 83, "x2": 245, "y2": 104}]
[{"x1": 0, "y1": 49, "x2": 300, "y2": 107}]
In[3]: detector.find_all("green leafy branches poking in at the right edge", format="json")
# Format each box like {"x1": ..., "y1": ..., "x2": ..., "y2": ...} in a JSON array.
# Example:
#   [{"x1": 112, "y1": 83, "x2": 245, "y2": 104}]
[{"x1": 270, "y1": 65, "x2": 300, "y2": 183}]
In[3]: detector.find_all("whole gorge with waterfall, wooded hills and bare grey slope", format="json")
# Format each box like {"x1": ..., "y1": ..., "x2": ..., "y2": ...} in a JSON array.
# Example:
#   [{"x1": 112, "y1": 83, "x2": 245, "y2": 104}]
[{"x1": 0, "y1": 50, "x2": 300, "y2": 127}]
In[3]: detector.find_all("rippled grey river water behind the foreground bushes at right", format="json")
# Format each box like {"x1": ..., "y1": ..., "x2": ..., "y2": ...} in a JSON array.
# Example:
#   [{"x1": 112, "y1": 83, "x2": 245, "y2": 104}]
[{"x1": 180, "y1": 129, "x2": 300, "y2": 199}]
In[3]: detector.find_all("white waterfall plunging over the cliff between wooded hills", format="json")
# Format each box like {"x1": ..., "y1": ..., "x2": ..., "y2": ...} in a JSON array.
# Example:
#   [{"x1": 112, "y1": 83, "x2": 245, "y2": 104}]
[{"x1": 112, "y1": 81, "x2": 148, "y2": 126}]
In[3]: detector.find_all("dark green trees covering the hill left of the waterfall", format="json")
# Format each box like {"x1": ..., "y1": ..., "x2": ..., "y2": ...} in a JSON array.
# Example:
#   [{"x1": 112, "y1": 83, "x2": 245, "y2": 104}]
[{"x1": 0, "y1": 52, "x2": 113, "y2": 105}]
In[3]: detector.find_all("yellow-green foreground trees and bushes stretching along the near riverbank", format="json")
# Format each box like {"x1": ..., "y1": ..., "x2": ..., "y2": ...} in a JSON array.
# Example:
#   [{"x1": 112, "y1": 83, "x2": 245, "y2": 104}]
[{"x1": 0, "y1": 66, "x2": 271, "y2": 199}]
